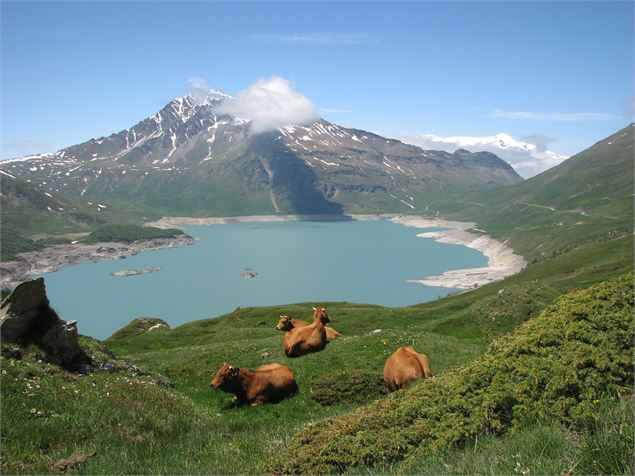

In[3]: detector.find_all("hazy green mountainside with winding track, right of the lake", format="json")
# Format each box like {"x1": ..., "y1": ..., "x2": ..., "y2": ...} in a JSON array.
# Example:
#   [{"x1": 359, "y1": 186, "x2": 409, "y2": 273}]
[{"x1": 441, "y1": 124, "x2": 635, "y2": 260}]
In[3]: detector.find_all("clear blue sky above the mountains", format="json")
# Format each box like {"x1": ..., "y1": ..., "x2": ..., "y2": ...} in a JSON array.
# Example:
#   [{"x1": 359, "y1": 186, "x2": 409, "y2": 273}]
[{"x1": 1, "y1": 1, "x2": 634, "y2": 162}]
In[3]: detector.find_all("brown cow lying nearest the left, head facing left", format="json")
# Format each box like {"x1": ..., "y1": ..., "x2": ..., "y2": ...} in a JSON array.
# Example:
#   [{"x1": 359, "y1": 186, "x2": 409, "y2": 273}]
[{"x1": 210, "y1": 364, "x2": 298, "y2": 407}]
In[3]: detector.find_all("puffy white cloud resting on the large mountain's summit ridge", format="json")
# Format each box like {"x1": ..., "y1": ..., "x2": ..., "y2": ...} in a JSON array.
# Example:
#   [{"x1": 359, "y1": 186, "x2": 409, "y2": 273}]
[{"x1": 217, "y1": 76, "x2": 318, "y2": 134}]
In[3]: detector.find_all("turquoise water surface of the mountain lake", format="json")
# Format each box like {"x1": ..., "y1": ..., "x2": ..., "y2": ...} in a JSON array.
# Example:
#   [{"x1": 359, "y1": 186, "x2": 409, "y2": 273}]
[{"x1": 39, "y1": 221, "x2": 487, "y2": 339}]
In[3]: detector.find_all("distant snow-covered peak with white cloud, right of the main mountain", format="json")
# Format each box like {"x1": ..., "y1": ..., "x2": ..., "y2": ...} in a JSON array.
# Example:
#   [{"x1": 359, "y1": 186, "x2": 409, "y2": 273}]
[{"x1": 401, "y1": 132, "x2": 568, "y2": 178}]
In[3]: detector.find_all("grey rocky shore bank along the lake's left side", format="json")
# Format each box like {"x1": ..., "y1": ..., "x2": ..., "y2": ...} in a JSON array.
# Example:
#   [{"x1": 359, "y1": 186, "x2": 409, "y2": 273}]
[{"x1": 0, "y1": 234, "x2": 195, "y2": 288}]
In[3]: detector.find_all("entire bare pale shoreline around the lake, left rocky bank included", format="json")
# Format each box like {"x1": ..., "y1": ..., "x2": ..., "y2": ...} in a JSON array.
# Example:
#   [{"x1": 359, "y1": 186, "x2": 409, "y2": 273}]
[{"x1": 0, "y1": 214, "x2": 527, "y2": 289}]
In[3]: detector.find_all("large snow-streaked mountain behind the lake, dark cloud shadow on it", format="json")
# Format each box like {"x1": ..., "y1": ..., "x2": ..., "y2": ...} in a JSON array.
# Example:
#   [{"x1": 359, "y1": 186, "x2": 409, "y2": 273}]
[{"x1": 0, "y1": 90, "x2": 522, "y2": 216}]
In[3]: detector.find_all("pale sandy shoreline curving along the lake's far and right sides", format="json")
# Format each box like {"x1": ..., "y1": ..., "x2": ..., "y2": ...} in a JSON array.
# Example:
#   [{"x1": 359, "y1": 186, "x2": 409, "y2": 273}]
[{"x1": 146, "y1": 214, "x2": 527, "y2": 289}]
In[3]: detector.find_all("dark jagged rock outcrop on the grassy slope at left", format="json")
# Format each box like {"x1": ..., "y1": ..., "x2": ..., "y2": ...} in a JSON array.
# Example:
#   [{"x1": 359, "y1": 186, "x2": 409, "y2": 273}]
[{"x1": 0, "y1": 278, "x2": 90, "y2": 370}]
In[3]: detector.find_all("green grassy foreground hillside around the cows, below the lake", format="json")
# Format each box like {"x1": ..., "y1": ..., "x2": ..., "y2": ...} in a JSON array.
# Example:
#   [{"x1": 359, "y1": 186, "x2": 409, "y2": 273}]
[{"x1": 1, "y1": 231, "x2": 633, "y2": 474}]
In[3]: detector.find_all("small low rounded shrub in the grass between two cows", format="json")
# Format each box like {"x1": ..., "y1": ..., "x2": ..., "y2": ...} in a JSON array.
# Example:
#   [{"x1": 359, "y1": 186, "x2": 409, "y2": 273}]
[{"x1": 309, "y1": 369, "x2": 388, "y2": 406}]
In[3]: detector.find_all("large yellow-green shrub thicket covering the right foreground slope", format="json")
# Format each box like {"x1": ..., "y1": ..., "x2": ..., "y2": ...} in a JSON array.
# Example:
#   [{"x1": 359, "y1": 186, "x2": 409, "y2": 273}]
[{"x1": 275, "y1": 274, "x2": 634, "y2": 474}]
